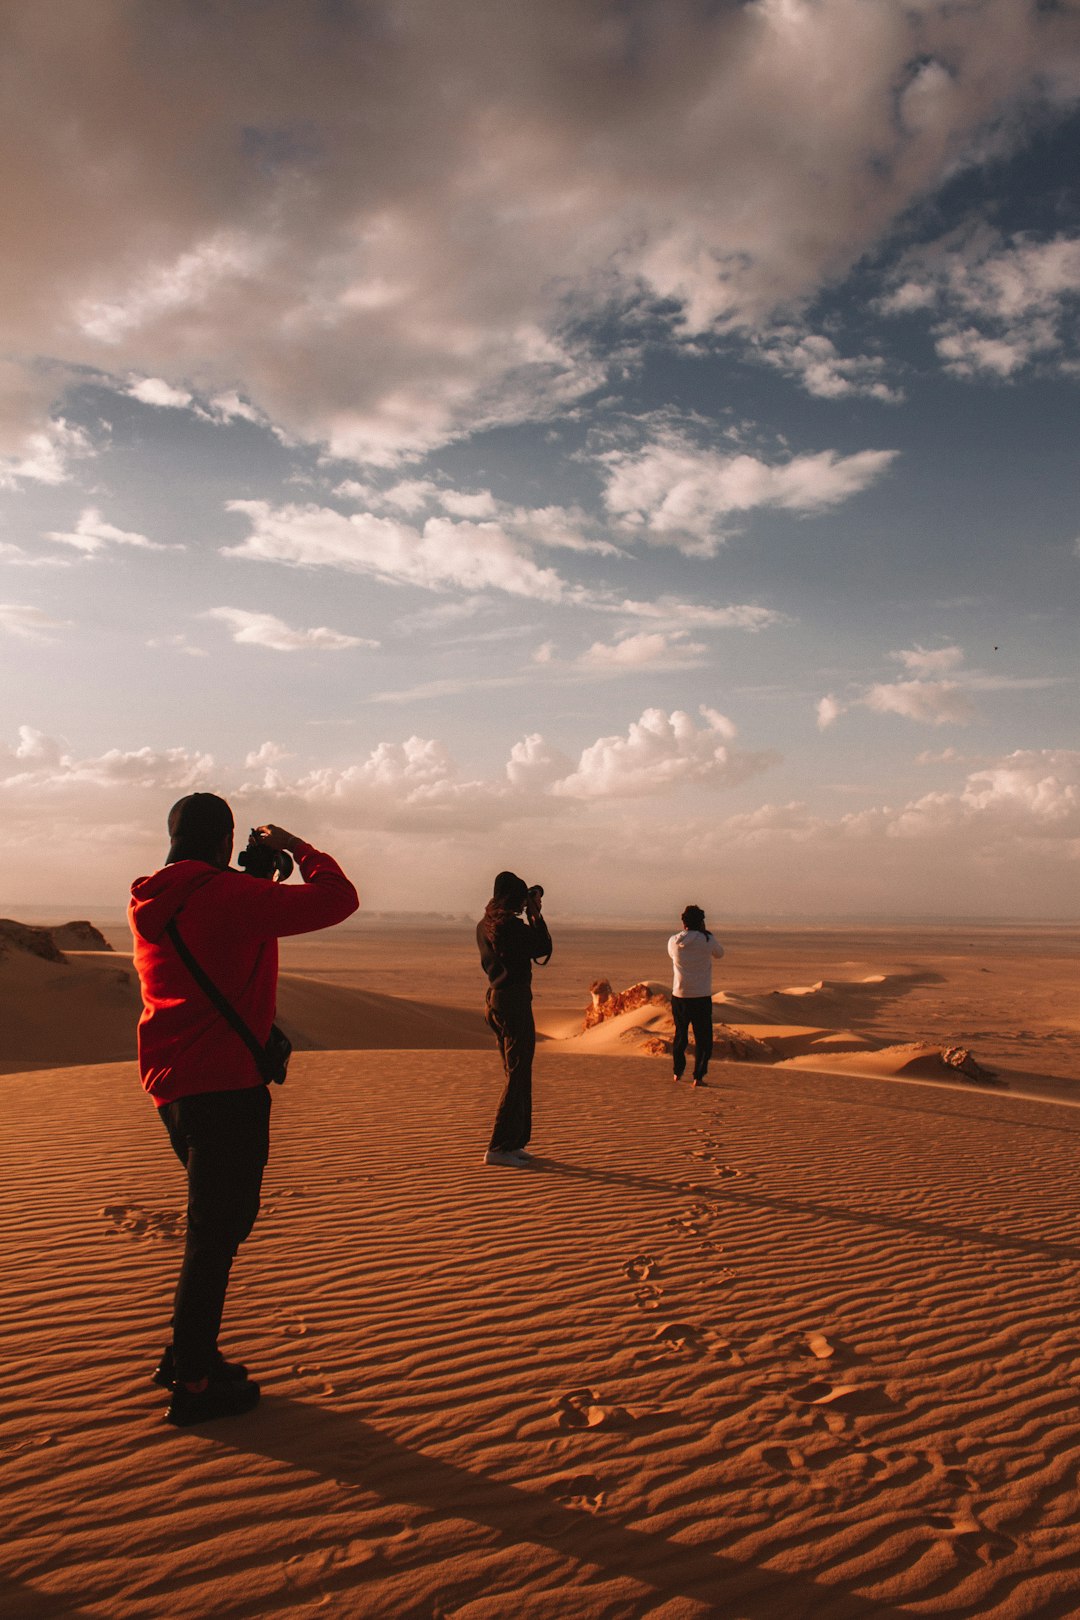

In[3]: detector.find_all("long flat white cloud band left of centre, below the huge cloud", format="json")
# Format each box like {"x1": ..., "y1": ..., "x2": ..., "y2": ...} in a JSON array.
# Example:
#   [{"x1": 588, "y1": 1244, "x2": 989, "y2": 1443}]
[{"x1": 225, "y1": 501, "x2": 565, "y2": 601}]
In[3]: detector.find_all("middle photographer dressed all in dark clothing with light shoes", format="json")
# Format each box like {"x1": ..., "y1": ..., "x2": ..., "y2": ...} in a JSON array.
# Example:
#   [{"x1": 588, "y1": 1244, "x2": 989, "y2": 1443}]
[{"x1": 476, "y1": 872, "x2": 552, "y2": 1165}]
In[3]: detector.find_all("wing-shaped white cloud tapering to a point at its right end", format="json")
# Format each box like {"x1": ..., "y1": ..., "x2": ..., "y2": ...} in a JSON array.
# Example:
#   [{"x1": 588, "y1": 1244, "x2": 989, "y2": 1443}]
[{"x1": 604, "y1": 434, "x2": 897, "y2": 556}]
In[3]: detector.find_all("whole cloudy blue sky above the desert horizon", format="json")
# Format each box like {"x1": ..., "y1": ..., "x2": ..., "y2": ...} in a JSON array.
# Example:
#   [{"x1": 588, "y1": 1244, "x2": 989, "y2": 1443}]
[{"x1": 0, "y1": 0, "x2": 1080, "y2": 922}]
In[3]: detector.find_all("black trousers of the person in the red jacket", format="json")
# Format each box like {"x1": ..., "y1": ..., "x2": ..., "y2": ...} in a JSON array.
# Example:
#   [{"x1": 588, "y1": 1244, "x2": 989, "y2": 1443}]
[{"x1": 160, "y1": 1085, "x2": 270, "y2": 1383}]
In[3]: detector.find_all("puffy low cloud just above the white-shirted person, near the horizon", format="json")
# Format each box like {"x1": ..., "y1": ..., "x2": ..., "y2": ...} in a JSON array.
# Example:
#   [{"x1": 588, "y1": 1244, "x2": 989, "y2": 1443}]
[{"x1": 551, "y1": 705, "x2": 774, "y2": 800}]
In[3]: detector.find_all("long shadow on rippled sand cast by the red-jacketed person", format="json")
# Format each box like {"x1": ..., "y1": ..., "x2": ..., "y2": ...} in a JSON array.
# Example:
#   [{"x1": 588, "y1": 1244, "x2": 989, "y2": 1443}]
[{"x1": 216, "y1": 1396, "x2": 904, "y2": 1620}]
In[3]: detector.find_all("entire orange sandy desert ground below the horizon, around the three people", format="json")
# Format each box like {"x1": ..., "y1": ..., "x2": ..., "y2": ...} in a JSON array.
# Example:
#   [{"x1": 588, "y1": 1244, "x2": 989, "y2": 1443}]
[{"x1": 0, "y1": 914, "x2": 1080, "y2": 1620}]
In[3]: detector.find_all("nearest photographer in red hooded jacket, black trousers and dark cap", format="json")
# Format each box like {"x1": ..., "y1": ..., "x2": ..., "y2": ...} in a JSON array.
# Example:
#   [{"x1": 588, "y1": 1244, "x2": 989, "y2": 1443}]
[{"x1": 128, "y1": 794, "x2": 359, "y2": 1426}]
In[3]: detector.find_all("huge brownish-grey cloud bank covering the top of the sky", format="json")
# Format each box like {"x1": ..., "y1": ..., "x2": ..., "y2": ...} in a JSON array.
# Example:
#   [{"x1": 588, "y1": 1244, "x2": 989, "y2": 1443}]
[{"x1": 0, "y1": 0, "x2": 1078, "y2": 462}]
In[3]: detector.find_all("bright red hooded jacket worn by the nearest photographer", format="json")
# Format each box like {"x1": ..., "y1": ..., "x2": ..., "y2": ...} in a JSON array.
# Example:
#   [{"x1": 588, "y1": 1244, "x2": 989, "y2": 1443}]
[{"x1": 128, "y1": 839, "x2": 359, "y2": 1108}]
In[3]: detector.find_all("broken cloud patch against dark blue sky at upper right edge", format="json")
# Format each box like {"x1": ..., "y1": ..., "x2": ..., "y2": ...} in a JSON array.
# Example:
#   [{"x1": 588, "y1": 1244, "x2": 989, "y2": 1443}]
[{"x1": 881, "y1": 224, "x2": 1080, "y2": 377}]
